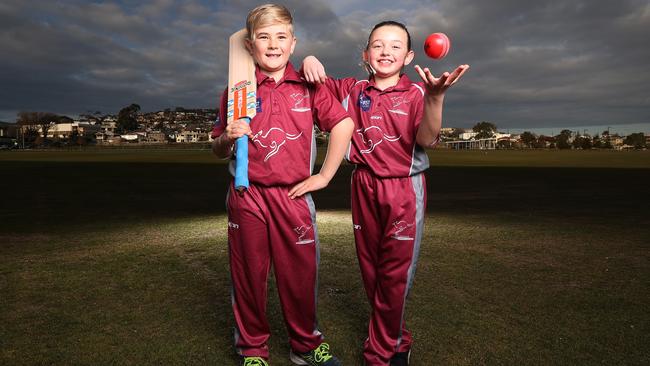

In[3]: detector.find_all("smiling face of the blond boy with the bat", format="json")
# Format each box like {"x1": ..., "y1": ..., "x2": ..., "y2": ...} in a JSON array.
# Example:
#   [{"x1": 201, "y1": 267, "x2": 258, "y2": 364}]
[{"x1": 247, "y1": 23, "x2": 296, "y2": 81}]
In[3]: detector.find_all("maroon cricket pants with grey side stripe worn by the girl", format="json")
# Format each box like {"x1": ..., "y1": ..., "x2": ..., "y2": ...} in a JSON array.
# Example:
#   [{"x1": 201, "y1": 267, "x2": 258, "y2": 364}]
[{"x1": 352, "y1": 167, "x2": 426, "y2": 366}]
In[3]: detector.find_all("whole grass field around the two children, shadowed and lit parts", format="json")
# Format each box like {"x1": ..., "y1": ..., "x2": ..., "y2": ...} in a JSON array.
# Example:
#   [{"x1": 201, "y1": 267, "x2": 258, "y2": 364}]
[{"x1": 0, "y1": 149, "x2": 650, "y2": 365}]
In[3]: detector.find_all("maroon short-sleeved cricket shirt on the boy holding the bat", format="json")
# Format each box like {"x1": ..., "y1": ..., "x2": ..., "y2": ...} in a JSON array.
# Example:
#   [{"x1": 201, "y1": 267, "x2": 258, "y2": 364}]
[{"x1": 212, "y1": 63, "x2": 348, "y2": 186}]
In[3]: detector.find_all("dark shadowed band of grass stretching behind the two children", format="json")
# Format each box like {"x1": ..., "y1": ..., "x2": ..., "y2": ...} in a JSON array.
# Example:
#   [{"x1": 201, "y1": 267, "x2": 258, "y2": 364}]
[{"x1": 0, "y1": 162, "x2": 650, "y2": 233}]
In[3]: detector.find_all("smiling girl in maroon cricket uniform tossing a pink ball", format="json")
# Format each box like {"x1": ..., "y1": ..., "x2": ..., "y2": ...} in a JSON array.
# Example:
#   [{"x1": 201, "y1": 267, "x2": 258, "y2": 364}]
[{"x1": 302, "y1": 21, "x2": 469, "y2": 366}]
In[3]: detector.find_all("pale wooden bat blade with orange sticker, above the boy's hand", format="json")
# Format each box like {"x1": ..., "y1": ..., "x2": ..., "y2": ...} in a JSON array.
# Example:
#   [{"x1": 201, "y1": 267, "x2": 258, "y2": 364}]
[{"x1": 226, "y1": 29, "x2": 257, "y2": 122}]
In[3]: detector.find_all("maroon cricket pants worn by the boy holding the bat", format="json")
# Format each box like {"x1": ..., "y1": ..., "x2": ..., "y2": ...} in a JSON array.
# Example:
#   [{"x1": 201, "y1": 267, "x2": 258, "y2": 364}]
[{"x1": 227, "y1": 184, "x2": 323, "y2": 358}]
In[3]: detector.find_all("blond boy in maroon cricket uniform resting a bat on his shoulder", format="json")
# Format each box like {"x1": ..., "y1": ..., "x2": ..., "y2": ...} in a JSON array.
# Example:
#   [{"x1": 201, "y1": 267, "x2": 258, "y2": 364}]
[{"x1": 213, "y1": 4, "x2": 353, "y2": 366}]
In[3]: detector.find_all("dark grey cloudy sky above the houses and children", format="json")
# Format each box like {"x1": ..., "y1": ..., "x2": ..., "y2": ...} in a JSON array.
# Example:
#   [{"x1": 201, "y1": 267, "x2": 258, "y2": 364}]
[{"x1": 0, "y1": 0, "x2": 650, "y2": 132}]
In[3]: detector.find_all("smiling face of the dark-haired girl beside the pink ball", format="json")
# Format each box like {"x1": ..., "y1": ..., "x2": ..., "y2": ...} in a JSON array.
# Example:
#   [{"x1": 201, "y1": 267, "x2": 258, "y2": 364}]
[{"x1": 362, "y1": 25, "x2": 414, "y2": 79}]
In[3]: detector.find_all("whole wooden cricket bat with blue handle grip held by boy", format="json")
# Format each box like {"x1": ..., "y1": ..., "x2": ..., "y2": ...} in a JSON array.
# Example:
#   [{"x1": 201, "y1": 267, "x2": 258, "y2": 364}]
[{"x1": 227, "y1": 29, "x2": 257, "y2": 193}]
